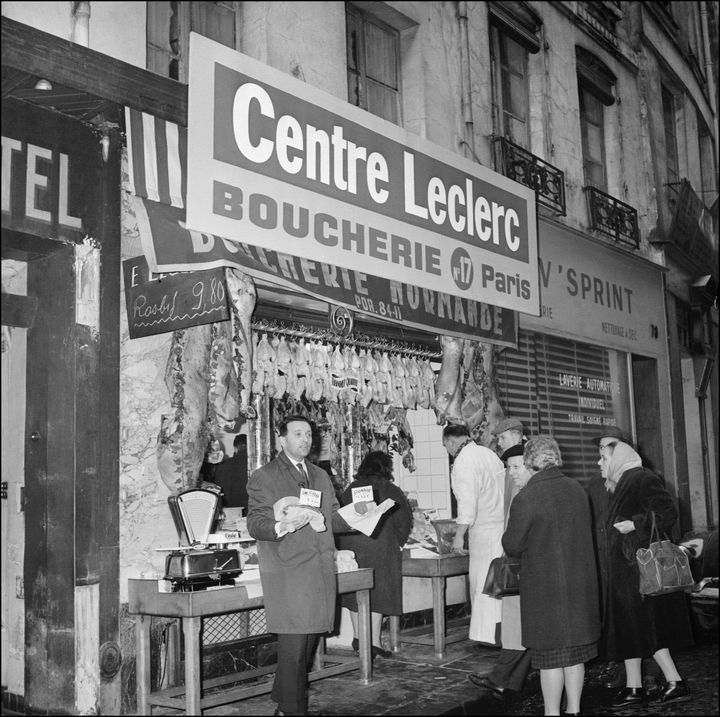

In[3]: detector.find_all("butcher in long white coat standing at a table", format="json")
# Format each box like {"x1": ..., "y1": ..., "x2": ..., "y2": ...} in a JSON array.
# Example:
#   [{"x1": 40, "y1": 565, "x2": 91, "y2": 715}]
[{"x1": 443, "y1": 424, "x2": 505, "y2": 645}]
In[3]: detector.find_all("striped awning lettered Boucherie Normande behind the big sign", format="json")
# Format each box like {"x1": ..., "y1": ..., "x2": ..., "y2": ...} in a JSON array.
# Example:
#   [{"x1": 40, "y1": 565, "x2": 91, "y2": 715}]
[{"x1": 126, "y1": 108, "x2": 517, "y2": 347}]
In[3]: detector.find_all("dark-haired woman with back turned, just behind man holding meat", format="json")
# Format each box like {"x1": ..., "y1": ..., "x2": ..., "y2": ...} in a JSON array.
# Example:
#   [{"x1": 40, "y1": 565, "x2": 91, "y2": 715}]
[{"x1": 337, "y1": 451, "x2": 413, "y2": 657}]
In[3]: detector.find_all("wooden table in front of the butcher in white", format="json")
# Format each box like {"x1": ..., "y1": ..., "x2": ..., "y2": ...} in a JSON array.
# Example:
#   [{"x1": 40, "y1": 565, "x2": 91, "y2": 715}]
[{"x1": 390, "y1": 554, "x2": 470, "y2": 658}]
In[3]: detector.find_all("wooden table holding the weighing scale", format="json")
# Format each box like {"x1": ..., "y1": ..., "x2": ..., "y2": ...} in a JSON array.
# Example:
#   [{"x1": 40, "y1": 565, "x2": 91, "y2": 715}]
[{"x1": 128, "y1": 568, "x2": 374, "y2": 715}]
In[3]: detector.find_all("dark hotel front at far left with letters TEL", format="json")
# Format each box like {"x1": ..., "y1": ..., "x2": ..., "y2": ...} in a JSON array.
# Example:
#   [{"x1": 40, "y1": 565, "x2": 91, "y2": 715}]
[{"x1": 2, "y1": 93, "x2": 119, "y2": 714}]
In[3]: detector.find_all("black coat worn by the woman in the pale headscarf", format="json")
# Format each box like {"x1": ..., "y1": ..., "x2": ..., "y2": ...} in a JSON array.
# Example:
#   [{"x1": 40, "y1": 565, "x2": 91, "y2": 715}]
[{"x1": 603, "y1": 467, "x2": 693, "y2": 660}]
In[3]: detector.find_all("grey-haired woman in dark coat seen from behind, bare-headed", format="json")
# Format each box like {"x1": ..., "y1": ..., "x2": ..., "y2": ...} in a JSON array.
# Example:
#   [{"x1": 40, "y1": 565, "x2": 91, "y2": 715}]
[{"x1": 502, "y1": 436, "x2": 600, "y2": 715}]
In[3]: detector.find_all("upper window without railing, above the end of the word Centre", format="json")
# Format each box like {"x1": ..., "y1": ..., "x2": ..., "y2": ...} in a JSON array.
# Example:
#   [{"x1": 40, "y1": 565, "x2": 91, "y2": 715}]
[{"x1": 346, "y1": 4, "x2": 400, "y2": 124}]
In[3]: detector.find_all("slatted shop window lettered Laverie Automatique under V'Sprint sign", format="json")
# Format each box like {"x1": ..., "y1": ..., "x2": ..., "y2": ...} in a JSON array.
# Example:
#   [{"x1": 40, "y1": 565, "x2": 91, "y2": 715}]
[{"x1": 496, "y1": 331, "x2": 630, "y2": 481}]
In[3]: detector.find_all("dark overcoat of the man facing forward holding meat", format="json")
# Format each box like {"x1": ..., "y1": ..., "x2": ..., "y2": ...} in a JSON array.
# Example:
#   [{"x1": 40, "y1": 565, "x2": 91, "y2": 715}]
[{"x1": 247, "y1": 452, "x2": 348, "y2": 635}]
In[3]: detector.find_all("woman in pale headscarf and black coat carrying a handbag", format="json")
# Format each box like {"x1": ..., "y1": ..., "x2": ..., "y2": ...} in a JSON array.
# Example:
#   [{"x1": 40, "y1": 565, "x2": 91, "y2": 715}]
[{"x1": 598, "y1": 442, "x2": 693, "y2": 707}]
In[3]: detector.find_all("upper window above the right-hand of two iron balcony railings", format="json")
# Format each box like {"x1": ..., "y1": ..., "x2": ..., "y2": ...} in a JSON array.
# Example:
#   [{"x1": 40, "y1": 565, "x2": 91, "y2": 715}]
[{"x1": 576, "y1": 47, "x2": 615, "y2": 192}]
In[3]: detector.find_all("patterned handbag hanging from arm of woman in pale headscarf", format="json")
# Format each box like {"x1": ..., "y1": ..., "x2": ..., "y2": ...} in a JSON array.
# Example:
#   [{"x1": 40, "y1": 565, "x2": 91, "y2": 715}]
[{"x1": 635, "y1": 513, "x2": 695, "y2": 595}]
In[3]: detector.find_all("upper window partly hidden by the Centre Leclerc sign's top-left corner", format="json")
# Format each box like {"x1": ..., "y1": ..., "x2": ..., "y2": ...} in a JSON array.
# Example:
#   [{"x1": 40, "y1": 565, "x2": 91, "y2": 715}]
[{"x1": 146, "y1": 2, "x2": 239, "y2": 83}]
